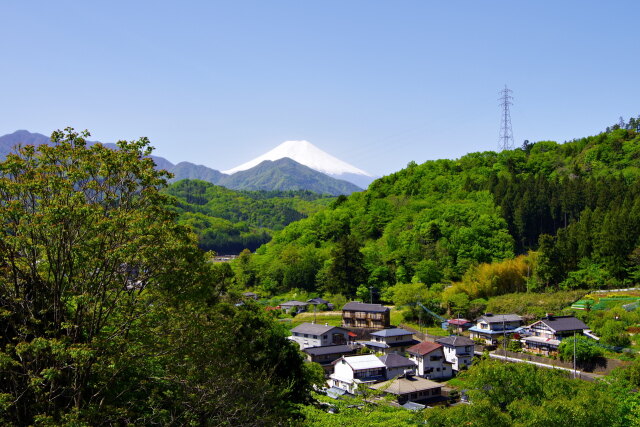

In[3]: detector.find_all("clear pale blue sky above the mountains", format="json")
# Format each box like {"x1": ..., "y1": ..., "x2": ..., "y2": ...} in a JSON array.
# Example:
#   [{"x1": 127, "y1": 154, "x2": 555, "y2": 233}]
[{"x1": 0, "y1": 0, "x2": 640, "y2": 175}]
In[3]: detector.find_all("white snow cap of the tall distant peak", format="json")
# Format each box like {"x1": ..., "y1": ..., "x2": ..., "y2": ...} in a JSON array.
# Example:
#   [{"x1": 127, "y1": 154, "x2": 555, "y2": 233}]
[{"x1": 222, "y1": 141, "x2": 372, "y2": 178}]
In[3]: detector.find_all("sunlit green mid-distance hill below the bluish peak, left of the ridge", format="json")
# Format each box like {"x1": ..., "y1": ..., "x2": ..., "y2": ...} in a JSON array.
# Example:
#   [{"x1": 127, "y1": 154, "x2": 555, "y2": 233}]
[{"x1": 165, "y1": 180, "x2": 333, "y2": 254}]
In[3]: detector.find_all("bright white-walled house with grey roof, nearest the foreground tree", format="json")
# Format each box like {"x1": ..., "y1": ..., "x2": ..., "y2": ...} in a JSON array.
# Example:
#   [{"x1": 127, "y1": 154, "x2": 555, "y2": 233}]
[{"x1": 327, "y1": 354, "x2": 386, "y2": 394}]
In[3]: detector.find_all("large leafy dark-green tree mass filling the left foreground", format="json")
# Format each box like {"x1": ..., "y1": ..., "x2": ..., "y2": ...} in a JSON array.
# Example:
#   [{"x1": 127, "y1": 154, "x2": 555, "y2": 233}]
[{"x1": 0, "y1": 129, "x2": 308, "y2": 425}]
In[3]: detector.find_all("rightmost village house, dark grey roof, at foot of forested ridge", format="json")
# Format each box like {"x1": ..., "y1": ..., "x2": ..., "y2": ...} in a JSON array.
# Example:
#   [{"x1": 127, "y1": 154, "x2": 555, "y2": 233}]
[{"x1": 520, "y1": 315, "x2": 597, "y2": 355}]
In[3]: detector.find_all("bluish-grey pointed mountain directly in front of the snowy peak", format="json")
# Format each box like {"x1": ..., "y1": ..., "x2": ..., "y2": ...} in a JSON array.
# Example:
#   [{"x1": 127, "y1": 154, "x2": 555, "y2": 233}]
[{"x1": 220, "y1": 158, "x2": 361, "y2": 195}]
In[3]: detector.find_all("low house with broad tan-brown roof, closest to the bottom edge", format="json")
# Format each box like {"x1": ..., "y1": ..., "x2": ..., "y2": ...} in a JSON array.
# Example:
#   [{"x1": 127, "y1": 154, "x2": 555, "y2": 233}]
[{"x1": 369, "y1": 374, "x2": 447, "y2": 405}]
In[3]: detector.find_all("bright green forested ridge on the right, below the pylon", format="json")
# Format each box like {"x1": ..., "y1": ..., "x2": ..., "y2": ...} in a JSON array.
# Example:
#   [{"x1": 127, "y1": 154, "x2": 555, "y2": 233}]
[{"x1": 237, "y1": 119, "x2": 640, "y2": 295}]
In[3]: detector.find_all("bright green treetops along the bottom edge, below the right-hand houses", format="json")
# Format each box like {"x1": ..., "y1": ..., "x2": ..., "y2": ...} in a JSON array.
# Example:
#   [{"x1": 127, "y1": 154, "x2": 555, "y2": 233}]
[{"x1": 424, "y1": 360, "x2": 627, "y2": 427}]
